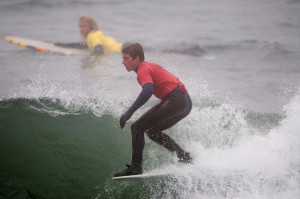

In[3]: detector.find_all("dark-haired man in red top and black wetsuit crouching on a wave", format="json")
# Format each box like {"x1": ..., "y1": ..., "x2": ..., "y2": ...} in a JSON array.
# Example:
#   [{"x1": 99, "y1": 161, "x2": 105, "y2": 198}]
[{"x1": 115, "y1": 43, "x2": 192, "y2": 177}]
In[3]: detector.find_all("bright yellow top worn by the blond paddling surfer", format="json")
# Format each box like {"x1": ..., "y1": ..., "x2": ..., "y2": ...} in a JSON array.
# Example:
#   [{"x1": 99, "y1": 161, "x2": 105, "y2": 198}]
[{"x1": 86, "y1": 30, "x2": 122, "y2": 52}]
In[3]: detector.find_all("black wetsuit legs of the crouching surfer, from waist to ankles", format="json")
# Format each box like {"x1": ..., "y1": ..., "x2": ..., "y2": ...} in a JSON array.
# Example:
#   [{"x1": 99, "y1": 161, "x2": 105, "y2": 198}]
[{"x1": 131, "y1": 87, "x2": 192, "y2": 164}]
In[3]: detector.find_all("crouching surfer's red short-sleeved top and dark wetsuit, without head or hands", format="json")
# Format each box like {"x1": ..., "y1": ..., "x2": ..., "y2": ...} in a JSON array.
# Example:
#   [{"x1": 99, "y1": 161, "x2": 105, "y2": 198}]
[{"x1": 129, "y1": 61, "x2": 192, "y2": 164}]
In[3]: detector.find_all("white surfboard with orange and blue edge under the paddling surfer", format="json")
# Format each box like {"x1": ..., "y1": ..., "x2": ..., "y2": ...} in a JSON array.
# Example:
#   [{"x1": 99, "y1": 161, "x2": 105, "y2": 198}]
[{"x1": 4, "y1": 36, "x2": 88, "y2": 55}]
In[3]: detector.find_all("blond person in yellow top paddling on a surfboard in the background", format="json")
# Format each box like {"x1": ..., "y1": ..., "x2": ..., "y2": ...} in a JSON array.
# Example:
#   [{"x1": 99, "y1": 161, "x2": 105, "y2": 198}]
[{"x1": 55, "y1": 16, "x2": 122, "y2": 55}]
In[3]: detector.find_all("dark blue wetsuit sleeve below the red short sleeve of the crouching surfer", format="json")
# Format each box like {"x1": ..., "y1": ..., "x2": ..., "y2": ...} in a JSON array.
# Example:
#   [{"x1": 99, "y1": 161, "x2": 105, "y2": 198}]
[{"x1": 129, "y1": 83, "x2": 153, "y2": 113}]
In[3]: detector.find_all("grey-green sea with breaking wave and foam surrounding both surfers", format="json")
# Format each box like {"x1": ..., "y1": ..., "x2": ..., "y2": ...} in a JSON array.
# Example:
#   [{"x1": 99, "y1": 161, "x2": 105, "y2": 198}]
[{"x1": 0, "y1": 0, "x2": 300, "y2": 199}]
